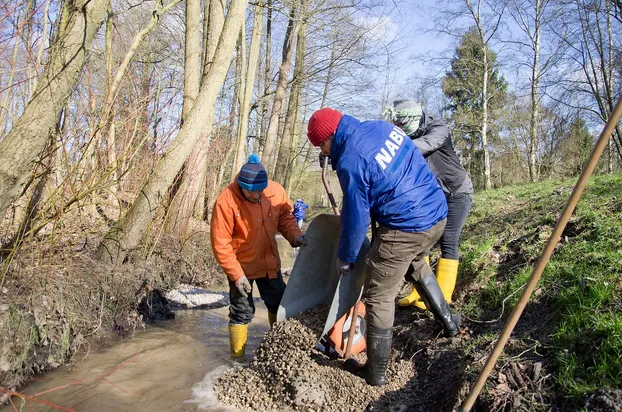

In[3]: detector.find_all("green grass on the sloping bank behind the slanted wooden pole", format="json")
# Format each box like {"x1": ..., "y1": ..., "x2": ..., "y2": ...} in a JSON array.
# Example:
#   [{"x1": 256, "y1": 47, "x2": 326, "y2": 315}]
[{"x1": 459, "y1": 174, "x2": 622, "y2": 409}]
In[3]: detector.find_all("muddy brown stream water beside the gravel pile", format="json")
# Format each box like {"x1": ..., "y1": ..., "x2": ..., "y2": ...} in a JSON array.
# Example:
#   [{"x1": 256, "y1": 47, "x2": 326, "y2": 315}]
[{"x1": 12, "y1": 303, "x2": 269, "y2": 411}]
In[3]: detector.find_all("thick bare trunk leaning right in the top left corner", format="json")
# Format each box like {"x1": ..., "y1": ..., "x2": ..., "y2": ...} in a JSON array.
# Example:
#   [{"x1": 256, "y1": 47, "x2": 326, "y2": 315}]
[{"x1": 0, "y1": 0, "x2": 110, "y2": 219}]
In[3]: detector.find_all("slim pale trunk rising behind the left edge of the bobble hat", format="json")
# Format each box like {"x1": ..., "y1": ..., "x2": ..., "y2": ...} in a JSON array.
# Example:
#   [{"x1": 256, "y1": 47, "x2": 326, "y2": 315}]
[{"x1": 233, "y1": 2, "x2": 263, "y2": 171}]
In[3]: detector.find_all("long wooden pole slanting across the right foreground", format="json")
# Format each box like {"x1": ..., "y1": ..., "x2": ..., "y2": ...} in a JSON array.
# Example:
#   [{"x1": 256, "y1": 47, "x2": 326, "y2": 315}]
[{"x1": 460, "y1": 97, "x2": 622, "y2": 412}]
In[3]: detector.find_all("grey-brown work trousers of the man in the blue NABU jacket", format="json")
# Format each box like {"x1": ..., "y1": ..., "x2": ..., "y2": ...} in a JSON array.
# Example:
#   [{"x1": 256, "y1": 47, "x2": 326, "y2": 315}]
[{"x1": 363, "y1": 219, "x2": 447, "y2": 329}]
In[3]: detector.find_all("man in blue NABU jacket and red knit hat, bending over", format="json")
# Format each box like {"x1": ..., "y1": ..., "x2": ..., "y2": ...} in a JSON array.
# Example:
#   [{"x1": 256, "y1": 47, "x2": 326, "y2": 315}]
[{"x1": 307, "y1": 108, "x2": 460, "y2": 386}]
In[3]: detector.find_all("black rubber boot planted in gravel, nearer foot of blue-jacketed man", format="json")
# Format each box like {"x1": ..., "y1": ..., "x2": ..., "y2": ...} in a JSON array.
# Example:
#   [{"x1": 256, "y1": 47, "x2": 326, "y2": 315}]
[{"x1": 345, "y1": 326, "x2": 393, "y2": 386}]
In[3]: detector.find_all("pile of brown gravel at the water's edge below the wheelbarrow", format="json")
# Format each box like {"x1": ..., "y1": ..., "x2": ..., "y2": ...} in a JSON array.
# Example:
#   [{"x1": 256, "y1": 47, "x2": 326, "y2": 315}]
[{"x1": 214, "y1": 306, "x2": 414, "y2": 411}]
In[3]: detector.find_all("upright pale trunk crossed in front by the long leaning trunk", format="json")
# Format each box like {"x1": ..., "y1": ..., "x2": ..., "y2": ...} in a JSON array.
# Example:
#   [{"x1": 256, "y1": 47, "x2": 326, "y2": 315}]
[{"x1": 166, "y1": 0, "x2": 204, "y2": 233}]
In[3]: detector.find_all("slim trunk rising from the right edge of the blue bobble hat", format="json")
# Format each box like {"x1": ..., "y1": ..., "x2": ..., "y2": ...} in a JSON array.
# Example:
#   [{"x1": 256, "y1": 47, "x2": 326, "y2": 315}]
[{"x1": 261, "y1": 5, "x2": 299, "y2": 168}]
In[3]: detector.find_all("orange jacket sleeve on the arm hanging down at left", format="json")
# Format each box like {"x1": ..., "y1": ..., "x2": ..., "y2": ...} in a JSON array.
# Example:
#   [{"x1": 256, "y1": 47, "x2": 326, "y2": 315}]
[{"x1": 210, "y1": 194, "x2": 244, "y2": 282}]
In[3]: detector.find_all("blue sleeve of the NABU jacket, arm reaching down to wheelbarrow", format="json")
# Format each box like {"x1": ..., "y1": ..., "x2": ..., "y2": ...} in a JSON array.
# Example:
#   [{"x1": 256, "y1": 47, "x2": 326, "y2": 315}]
[{"x1": 337, "y1": 162, "x2": 369, "y2": 263}]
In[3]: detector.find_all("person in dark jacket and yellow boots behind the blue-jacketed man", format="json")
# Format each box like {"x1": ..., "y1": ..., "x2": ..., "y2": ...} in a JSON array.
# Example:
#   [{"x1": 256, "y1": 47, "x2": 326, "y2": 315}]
[{"x1": 384, "y1": 99, "x2": 473, "y2": 309}]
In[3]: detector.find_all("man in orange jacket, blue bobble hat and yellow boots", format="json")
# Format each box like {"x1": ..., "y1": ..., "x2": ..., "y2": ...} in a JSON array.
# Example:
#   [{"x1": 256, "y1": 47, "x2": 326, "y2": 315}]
[{"x1": 210, "y1": 154, "x2": 307, "y2": 358}]
